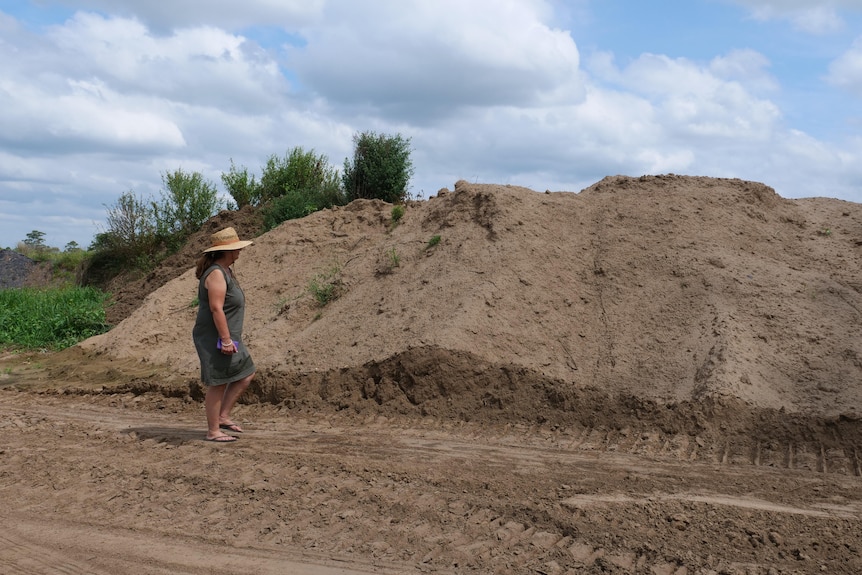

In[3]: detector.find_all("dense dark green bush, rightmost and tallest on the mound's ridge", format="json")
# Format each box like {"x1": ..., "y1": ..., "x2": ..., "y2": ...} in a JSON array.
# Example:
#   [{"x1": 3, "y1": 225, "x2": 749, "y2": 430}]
[{"x1": 342, "y1": 131, "x2": 413, "y2": 204}]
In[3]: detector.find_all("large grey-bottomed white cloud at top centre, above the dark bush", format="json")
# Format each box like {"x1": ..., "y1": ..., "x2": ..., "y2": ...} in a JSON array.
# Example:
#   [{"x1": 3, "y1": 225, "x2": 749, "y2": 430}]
[{"x1": 289, "y1": 0, "x2": 581, "y2": 121}]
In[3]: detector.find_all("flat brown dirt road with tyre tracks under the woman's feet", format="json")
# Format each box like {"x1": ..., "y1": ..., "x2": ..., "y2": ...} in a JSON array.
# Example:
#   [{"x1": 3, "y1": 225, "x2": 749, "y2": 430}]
[{"x1": 0, "y1": 382, "x2": 862, "y2": 575}]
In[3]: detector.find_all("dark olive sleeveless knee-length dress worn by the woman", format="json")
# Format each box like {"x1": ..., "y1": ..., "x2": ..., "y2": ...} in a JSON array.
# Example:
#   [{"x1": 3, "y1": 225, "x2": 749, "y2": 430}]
[{"x1": 192, "y1": 265, "x2": 255, "y2": 385}]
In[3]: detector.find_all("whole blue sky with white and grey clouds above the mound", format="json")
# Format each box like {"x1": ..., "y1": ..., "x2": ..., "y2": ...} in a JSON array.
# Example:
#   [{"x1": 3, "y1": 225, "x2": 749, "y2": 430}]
[{"x1": 0, "y1": 0, "x2": 862, "y2": 249}]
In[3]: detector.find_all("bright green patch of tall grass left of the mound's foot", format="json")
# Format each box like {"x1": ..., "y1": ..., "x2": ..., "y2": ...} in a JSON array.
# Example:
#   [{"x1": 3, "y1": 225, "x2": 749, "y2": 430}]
[{"x1": 0, "y1": 287, "x2": 110, "y2": 350}]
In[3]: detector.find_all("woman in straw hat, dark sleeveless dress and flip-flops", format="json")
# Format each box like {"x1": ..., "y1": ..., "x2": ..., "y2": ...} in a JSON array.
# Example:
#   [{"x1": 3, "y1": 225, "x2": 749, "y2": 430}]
[{"x1": 192, "y1": 228, "x2": 255, "y2": 443}]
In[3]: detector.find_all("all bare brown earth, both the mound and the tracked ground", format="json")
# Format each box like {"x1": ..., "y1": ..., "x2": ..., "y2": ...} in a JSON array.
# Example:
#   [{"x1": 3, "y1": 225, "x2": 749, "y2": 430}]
[{"x1": 0, "y1": 175, "x2": 862, "y2": 575}]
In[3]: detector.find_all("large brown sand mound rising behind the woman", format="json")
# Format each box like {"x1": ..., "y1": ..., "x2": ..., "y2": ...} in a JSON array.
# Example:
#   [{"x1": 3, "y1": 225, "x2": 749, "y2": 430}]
[{"x1": 80, "y1": 175, "x2": 862, "y2": 417}]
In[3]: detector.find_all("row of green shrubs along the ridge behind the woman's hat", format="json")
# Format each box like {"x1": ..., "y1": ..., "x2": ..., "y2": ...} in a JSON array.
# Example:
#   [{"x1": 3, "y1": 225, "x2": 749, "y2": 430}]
[{"x1": 89, "y1": 132, "x2": 413, "y2": 283}]
